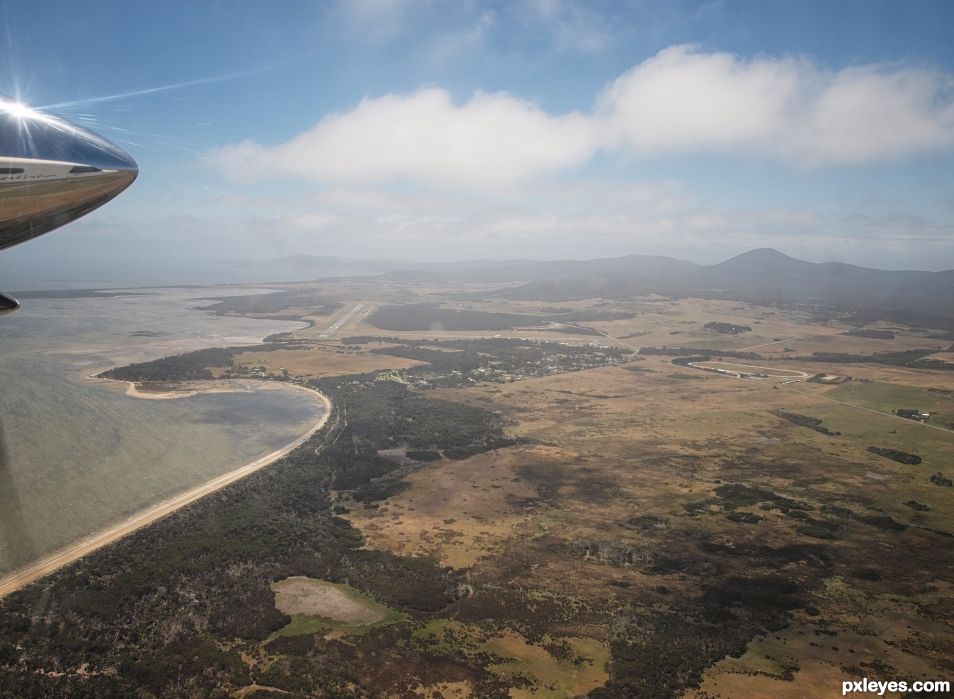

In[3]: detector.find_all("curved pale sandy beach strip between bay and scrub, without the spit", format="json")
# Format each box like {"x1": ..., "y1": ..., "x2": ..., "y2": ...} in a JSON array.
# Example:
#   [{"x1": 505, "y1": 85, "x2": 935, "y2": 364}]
[{"x1": 0, "y1": 384, "x2": 332, "y2": 597}]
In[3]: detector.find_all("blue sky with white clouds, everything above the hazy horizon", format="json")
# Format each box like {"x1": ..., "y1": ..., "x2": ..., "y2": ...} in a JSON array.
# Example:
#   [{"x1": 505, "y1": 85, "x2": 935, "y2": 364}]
[{"x1": 0, "y1": 0, "x2": 954, "y2": 287}]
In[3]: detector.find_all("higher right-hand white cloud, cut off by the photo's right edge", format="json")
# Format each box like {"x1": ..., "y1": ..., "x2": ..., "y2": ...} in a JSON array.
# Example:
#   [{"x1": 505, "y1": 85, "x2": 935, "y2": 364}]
[{"x1": 597, "y1": 46, "x2": 954, "y2": 167}]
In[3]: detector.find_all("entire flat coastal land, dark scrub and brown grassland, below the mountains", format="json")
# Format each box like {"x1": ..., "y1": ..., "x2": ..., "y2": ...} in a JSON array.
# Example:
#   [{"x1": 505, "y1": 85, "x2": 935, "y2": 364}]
[{"x1": 7, "y1": 282, "x2": 954, "y2": 699}]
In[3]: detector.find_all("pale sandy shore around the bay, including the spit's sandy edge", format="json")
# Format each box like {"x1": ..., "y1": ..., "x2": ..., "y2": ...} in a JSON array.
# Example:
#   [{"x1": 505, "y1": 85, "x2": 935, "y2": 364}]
[{"x1": 0, "y1": 375, "x2": 332, "y2": 599}]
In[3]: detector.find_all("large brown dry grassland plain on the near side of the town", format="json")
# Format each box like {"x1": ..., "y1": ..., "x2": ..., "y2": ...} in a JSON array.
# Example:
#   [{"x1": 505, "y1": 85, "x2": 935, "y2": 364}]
[{"x1": 342, "y1": 316, "x2": 954, "y2": 699}]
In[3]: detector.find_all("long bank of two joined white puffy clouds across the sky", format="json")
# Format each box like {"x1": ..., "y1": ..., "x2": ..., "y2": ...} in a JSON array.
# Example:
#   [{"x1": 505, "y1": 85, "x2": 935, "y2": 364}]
[{"x1": 212, "y1": 45, "x2": 954, "y2": 190}]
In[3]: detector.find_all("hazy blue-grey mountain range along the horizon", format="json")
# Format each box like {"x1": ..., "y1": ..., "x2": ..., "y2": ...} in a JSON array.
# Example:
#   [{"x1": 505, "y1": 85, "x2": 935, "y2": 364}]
[{"x1": 268, "y1": 248, "x2": 954, "y2": 327}]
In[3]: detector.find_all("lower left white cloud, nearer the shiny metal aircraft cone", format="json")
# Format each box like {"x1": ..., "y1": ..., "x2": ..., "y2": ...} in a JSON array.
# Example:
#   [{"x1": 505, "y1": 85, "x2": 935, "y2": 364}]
[{"x1": 216, "y1": 88, "x2": 595, "y2": 189}]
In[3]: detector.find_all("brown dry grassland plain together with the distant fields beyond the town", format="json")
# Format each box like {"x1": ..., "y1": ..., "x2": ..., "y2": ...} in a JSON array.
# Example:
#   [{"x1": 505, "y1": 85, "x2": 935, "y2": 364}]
[{"x1": 248, "y1": 285, "x2": 954, "y2": 699}]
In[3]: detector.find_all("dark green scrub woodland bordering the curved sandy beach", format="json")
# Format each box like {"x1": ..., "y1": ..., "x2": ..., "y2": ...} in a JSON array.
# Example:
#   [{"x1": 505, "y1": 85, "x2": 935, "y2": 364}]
[{"x1": 0, "y1": 338, "x2": 519, "y2": 697}]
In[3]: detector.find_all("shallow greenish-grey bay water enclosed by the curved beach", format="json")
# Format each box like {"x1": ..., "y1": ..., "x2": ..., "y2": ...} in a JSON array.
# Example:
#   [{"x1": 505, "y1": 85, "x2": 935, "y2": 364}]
[{"x1": 0, "y1": 288, "x2": 323, "y2": 574}]
